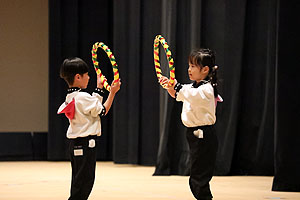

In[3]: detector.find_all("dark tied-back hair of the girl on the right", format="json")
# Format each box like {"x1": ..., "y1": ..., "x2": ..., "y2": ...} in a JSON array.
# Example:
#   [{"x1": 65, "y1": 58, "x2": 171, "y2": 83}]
[{"x1": 188, "y1": 48, "x2": 218, "y2": 97}]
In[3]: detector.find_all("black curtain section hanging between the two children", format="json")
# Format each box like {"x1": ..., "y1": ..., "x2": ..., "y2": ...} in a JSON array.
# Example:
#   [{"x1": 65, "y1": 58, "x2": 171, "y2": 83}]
[{"x1": 113, "y1": 0, "x2": 161, "y2": 165}]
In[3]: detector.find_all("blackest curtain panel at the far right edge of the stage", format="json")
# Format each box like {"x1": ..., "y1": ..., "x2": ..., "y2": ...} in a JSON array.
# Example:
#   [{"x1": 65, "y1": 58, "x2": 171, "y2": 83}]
[{"x1": 272, "y1": 0, "x2": 300, "y2": 192}]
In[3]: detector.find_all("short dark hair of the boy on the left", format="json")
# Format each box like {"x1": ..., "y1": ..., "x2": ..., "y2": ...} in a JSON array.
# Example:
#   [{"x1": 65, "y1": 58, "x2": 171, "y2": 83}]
[{"x1": 60, "y1": 57, "x2": 89, "y2": 85}]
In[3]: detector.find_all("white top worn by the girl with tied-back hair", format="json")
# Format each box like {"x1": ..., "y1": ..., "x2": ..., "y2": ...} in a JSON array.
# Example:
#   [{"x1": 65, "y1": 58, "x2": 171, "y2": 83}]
[{"x1": 176, "y1": 83, "x2": 216, "y2": 127}]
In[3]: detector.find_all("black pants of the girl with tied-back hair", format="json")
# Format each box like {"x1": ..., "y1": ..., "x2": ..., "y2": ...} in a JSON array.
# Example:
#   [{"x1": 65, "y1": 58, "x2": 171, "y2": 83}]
[{"x1": 186, "y1": 125, "x2": 218, "y2": 200}]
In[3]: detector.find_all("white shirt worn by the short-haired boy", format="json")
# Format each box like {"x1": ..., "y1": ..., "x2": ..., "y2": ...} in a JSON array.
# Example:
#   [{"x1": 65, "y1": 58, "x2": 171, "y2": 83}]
[{"x1": 58, "y1": 91, "x2": 104, "y2": 139}]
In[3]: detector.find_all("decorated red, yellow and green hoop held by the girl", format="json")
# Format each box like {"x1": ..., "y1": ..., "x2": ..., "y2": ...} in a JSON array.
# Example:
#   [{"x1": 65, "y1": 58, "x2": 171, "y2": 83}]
[{"x1": 153, "y1": 35, "x2": 175, "y2": 88}]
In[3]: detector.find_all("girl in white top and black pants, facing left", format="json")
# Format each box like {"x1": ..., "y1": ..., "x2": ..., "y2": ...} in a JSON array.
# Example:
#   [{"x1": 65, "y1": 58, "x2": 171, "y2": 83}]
[{"x1": 159, "y1": 49, "x2": 222, "y2": 200}]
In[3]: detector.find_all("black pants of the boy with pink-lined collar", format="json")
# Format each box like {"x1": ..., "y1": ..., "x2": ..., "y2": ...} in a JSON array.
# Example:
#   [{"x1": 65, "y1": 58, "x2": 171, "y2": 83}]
[{"x1": 69, "y1": 136, "x2": 97, "y2": 200}]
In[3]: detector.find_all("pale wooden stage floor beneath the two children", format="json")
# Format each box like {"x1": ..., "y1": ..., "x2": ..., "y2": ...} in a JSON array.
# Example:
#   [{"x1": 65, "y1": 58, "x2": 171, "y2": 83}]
[{"x1": 0, "y1": 161, "x2": 300, "y2": 200}]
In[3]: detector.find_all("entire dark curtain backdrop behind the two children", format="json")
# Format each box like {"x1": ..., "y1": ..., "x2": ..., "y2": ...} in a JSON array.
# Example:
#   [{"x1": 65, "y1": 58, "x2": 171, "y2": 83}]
[{"x1": 48, "y1": 0, "x2": 300, "y2": 191}]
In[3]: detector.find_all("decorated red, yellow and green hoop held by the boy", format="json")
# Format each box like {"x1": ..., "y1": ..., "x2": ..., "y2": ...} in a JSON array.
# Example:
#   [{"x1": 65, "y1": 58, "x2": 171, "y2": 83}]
[{"x1": 92, "y1": 42, "x2": 119, "y2": 92}]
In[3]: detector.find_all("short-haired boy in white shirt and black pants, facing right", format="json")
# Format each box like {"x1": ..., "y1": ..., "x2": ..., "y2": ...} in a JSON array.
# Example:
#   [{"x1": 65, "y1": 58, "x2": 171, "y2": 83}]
[{"x1": 58, "y1": 58, "x2": 121, "y2": 200}]
